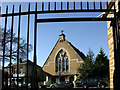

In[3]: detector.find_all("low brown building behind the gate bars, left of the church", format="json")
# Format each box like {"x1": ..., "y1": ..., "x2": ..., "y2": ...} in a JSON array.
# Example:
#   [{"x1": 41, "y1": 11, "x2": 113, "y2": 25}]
[{"x1": 5, "y1": 60, "x2": 46, "y2": 85}]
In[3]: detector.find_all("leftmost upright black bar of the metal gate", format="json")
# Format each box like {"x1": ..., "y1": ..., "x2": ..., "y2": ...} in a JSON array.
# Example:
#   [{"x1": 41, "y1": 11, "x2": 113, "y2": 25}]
[{"x1": 2, "y1": 6, "x2": 8, "y2": 88}]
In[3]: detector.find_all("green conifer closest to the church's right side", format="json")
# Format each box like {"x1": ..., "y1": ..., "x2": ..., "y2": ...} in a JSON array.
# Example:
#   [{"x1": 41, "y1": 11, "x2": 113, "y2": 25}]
[{"x1": 78, "y1": 49, "x2": 94, "y2": 78}]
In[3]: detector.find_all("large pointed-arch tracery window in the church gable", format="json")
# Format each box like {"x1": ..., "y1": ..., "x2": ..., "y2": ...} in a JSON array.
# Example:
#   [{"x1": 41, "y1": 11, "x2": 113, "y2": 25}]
[{"x1": 55, "y1": 50, "x2": 69, "y2": 72}]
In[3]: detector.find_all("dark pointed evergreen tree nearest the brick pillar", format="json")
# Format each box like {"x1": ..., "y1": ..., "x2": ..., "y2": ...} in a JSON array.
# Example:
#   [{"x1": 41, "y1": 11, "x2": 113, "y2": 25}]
[{"x1": 94, "y1": 48, "x2": 109, "y2": 78}]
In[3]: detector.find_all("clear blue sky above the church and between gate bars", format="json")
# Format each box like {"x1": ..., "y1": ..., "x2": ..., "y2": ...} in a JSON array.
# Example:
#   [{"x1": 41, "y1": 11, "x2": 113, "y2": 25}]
[{"x1": 2, "y1": 2, "x2": 109, "y2": 66}]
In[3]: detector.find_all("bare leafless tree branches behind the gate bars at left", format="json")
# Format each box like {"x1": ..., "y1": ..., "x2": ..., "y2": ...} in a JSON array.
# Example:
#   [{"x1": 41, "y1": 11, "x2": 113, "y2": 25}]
[{"x1": 0, "y1": 29, "x2": 32, "y2": 62}]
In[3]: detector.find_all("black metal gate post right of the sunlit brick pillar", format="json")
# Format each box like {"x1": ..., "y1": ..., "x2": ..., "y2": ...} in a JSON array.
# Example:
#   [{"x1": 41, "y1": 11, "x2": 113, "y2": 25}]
[{"x1": 113, "y1": 11, "x2": 120, "y2": 90}]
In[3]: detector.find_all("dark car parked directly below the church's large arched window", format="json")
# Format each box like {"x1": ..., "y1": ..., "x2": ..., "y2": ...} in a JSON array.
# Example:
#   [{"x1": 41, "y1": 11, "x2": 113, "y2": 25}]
[{"x1": 50, "y1": 82, "x2": 73, "y2": 88}]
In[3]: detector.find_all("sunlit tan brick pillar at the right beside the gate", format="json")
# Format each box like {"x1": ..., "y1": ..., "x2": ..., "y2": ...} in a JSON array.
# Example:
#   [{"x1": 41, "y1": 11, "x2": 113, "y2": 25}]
[{"x1": 107, "y1": 0, "x2": 118, "y2": 90}]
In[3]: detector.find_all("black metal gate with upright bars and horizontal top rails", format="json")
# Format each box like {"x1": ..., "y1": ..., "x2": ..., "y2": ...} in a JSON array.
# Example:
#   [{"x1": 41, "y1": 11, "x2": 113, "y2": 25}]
[{"x1": 1, "y1": 1, "x2": 120, "y2": 89}]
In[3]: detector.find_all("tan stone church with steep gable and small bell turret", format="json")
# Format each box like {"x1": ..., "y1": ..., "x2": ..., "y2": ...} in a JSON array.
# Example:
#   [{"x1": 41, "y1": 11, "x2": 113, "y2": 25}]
[{"x1": 43, "y1": 31, "x2": 85, "y2": 86}]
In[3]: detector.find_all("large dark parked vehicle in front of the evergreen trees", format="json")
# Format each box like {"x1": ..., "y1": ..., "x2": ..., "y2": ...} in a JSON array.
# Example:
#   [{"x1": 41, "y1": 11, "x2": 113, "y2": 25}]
[{"x1": 76, "y1": 78, "x2": 108, "y2": 88}]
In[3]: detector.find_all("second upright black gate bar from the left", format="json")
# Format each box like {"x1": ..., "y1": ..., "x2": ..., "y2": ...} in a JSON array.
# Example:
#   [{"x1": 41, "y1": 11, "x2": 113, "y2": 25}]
[{"x1": 10, "y1": 5, "x2": 14, "y2": 87}]
